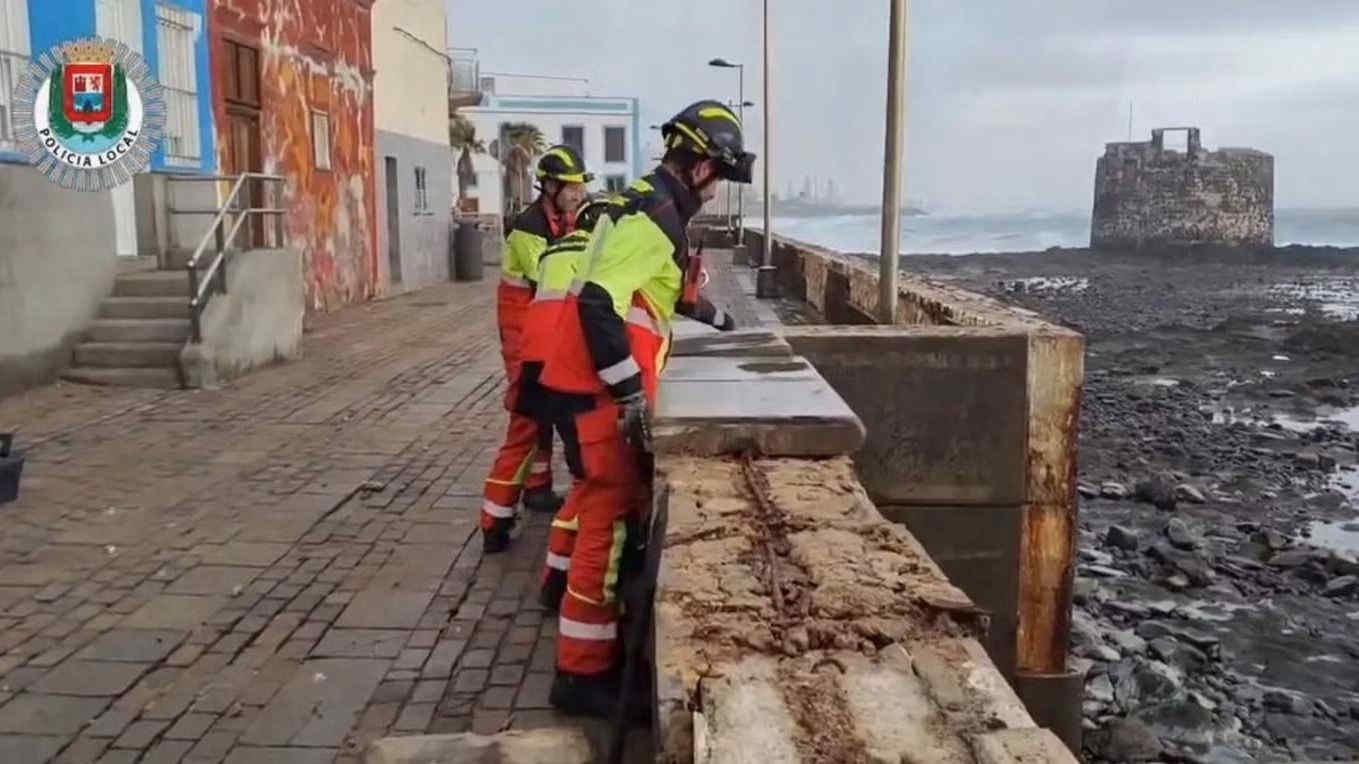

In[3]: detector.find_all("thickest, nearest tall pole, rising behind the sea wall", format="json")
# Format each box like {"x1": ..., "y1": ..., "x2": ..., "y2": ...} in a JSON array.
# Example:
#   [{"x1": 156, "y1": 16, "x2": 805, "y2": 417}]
[{"x1": 878, "y1": 0, "x2": 906, "y2": 324}]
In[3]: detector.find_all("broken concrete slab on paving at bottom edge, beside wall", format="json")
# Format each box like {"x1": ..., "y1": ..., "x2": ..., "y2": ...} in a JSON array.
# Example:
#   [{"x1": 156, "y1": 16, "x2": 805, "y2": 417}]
[{"x1": 363, "y1": 727, "x2": 597, "y2": 764}]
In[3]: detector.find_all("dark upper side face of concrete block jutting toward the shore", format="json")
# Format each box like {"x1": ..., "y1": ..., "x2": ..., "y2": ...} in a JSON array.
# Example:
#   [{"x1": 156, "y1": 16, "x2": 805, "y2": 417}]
[{"x1": 783, "y1": 326, "x2": 1027, "y2": 504}]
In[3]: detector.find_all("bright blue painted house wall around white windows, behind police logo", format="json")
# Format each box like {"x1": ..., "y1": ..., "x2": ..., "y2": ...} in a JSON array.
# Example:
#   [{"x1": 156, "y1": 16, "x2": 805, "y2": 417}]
[{"x1": 0, "y1": 0, "x2": 217, "y2": 173}]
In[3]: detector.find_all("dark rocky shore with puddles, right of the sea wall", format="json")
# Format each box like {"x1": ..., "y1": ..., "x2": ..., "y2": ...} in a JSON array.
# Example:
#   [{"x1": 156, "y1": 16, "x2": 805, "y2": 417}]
[{"x1": 904, "y1": 247, "x2": 1359, "y2": 763}]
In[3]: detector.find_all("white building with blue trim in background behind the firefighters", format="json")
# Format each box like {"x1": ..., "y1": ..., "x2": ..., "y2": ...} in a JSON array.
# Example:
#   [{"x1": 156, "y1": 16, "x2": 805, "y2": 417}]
[{"x1": 453, "y1": 72, "x2": 648, "y2": 213}]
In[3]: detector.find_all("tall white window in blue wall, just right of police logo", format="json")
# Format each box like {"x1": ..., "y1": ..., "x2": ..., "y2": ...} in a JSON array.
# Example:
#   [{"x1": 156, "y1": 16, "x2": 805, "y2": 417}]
[{"x1": 156, "y1": 5, "x2": 202, "y2": 167}]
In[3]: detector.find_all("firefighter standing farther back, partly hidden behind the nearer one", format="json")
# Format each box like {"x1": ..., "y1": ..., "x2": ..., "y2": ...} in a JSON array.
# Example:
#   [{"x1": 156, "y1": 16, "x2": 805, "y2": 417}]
[{"x1": 481, "y1": 145, "x2": 594, "y2": 552}]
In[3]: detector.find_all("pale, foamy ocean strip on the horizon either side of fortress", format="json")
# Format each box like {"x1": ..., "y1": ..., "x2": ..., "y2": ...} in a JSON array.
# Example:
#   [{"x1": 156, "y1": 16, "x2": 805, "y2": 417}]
[{"x1": 746, "y1": 208, "x2": 1359, "y2": 254}]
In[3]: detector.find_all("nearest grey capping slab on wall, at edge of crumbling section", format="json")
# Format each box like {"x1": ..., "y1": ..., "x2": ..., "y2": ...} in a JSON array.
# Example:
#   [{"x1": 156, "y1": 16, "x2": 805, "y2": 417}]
[{"x1": 652, "y1": 370, "x2": 864, "y2": 457}]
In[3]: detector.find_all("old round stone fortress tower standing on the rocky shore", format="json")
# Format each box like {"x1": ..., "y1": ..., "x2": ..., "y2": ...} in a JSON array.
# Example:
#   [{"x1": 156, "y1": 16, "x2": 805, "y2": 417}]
[{"x1": 1090, "y1": 128, "x2": 1273, "y2": 249}]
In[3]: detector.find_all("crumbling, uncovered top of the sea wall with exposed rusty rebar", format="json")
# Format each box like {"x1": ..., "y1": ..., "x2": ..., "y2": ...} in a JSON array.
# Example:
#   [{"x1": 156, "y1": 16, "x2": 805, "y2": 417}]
[{"x1": 654, "y1": 455, "x2": 1070, "y2": 764}]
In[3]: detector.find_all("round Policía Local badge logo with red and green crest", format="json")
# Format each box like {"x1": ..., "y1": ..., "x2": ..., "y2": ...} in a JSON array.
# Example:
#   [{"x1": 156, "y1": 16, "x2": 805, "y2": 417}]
[{"x1": 15, "y1": 38, "x2": 166, "y2": 190}]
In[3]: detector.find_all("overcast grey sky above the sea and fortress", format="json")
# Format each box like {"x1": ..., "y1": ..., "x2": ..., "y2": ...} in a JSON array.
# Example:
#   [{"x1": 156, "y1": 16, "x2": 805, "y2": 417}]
[{"x1": 448, "y1": 0, "x2": 1359, "y2": 212}]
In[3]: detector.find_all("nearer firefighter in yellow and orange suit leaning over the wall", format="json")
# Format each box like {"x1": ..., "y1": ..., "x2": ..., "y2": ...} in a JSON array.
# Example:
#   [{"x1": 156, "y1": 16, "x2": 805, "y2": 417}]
[{"x1": 541, "y1": 101, "x2": 754, "y2": 715}]
